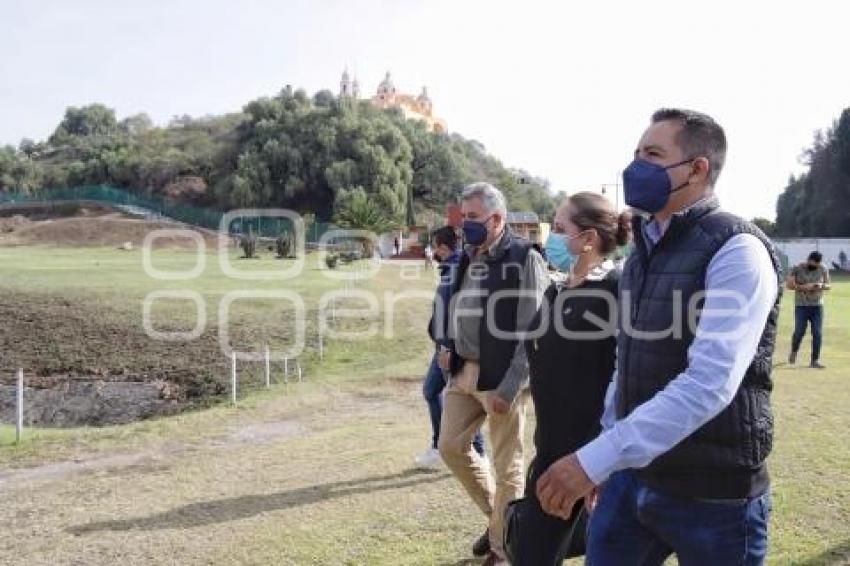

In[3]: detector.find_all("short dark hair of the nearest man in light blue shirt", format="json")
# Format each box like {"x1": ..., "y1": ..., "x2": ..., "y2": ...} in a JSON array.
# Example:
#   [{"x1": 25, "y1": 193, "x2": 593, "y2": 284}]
[{"x1": 652, "y1": 108, "x2": 726, "y2": 187}]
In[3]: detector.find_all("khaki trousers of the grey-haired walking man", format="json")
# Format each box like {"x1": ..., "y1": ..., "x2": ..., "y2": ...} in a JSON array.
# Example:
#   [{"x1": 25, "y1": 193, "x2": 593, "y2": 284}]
[{"x1": 439, "y1": 361, "x2": 528, "y2": 557}]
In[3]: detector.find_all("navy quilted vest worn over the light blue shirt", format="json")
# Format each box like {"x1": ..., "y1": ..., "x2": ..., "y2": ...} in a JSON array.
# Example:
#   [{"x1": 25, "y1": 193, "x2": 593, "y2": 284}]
[{"x1": 616, "y1": 198, "x2": 782, "y2": 499}]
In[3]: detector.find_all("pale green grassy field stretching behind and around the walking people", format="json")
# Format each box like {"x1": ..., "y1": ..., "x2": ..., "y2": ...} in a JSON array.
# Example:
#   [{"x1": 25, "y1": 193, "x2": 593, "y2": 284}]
[{"x1": 0, "y1": 247, "x2": 850, "y2": 565}]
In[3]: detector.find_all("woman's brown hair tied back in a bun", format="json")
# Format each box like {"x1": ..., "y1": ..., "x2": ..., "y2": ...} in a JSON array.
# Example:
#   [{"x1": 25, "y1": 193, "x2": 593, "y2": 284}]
[{"x1": 567, "y1": 191, "x2": 632, "y2": 255}]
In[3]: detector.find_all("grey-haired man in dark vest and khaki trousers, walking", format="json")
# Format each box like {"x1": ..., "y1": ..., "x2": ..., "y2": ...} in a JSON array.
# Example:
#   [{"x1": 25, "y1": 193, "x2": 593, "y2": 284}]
[{"x1": 438, "y1": 183, "x2": 549, "y2": 566}]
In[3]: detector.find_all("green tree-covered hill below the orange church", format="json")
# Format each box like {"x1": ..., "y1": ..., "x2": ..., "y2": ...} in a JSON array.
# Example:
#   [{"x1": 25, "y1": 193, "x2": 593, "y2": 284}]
[{"x1": 0, "y1": 87, "x2": 555, "y2": 223}]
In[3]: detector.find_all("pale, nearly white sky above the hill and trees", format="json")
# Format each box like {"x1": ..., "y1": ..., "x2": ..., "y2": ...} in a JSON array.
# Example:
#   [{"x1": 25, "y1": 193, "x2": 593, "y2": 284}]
[{"x1": 0, "y1": 0, "x2": 850, "y2": 218}]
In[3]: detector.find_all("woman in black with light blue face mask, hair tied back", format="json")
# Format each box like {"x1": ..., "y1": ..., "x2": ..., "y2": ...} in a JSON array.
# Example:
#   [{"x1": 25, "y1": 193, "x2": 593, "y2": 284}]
[{"x1": 507, "y1": 192, "x2": 630, "y2": 566}]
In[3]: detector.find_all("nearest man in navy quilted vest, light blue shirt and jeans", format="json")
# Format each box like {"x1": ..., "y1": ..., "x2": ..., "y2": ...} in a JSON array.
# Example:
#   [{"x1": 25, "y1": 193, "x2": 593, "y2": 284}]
[{"x1": 536, "y1": 109, "x2": 780, "y2": 566}]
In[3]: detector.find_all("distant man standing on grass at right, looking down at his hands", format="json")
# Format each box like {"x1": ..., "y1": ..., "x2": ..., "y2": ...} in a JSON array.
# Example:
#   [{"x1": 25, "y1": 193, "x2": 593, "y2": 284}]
[{"x1": 785, "y1": 251, "x2": 830, "y2": 369}]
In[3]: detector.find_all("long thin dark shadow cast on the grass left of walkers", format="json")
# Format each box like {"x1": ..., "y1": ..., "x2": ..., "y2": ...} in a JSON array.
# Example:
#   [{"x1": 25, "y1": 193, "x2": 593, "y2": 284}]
[{"x1": 68, "y1": 470, "x2": 451, "y2": 535}]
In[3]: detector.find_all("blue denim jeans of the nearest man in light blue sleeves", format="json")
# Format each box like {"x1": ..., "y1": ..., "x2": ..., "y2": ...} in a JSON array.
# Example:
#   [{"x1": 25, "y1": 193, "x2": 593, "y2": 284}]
[{"x1": 585, "y1": 470, "x2": 770, "y2": 566}]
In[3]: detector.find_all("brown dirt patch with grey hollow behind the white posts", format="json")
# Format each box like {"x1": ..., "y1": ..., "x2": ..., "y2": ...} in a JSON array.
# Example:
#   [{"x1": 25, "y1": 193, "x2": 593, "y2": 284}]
[{"x1": 0, "y1": 292, "x2": 312, "y2": 426}]
